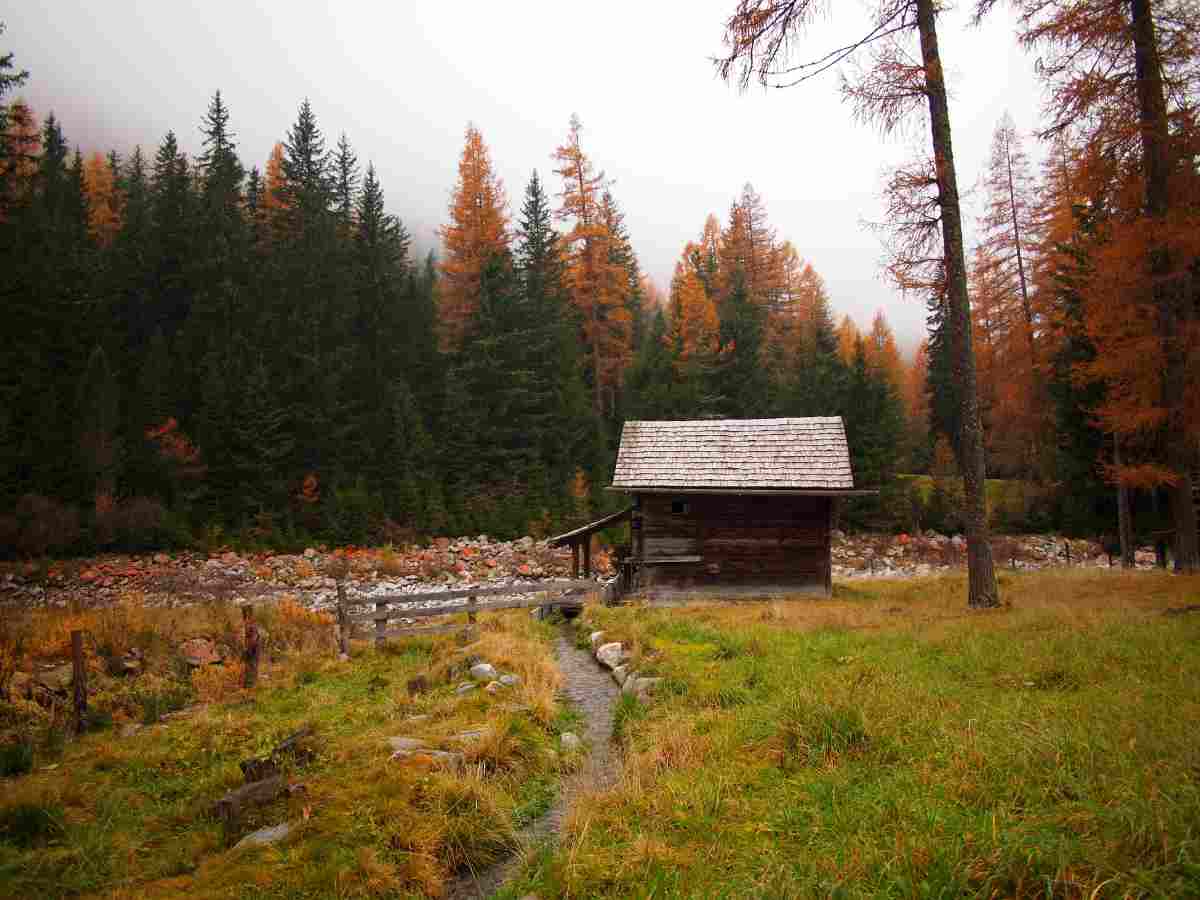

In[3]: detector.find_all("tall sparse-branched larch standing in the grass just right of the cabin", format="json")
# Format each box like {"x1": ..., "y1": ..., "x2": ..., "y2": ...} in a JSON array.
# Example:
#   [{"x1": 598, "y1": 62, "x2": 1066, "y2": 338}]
[{"x1": 715, "y1": 0, "x2": 1000, "y2": 608}]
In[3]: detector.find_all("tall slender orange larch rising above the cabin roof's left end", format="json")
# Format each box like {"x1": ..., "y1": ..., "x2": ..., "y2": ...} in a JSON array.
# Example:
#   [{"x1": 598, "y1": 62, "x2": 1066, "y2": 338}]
[{"x1": 552, "y1": 115, "x2": 632, "y2": 415}]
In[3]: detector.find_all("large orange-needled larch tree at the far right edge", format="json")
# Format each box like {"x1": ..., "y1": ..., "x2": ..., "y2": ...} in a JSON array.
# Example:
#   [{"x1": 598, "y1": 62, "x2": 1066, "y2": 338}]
[{"x1": 993, "y1": 0, "x2": 1200, "y2": 572}]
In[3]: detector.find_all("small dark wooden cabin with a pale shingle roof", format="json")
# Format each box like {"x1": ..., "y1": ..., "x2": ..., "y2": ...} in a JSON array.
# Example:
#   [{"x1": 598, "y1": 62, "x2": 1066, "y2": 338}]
[{"x1": 609, "y1": 416, "x2": 872, "y2": 598}]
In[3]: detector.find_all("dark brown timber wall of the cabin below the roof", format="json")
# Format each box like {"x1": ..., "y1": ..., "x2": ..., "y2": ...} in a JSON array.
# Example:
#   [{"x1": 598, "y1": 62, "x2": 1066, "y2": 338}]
[{"x1": 635, "y1": 494, "x2": 832, "y2": 594}]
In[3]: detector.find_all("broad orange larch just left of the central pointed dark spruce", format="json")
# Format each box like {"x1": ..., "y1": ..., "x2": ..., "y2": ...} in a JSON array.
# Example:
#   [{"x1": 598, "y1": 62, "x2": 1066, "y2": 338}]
[{"x1": 438, "y1": 125, "x2": 511, "y2": 352}]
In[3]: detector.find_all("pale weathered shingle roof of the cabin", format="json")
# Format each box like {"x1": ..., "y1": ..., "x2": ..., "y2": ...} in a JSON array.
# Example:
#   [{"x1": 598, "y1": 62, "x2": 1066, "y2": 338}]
[{"x1": 612, "y1": 415, "x2": 854, "y2": 491}]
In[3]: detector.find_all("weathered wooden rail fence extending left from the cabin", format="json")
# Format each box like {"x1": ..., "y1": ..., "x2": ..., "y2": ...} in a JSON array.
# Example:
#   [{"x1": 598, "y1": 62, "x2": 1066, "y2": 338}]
[{"x1": 337, "y1": 580, "x2": 604, "y2": 653}]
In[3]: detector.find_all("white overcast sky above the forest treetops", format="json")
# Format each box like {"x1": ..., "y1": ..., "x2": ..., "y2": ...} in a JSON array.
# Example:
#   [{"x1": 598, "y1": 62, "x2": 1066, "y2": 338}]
[{"x1": 7, "y1": 0, "x2": 1039, "y2": 348}]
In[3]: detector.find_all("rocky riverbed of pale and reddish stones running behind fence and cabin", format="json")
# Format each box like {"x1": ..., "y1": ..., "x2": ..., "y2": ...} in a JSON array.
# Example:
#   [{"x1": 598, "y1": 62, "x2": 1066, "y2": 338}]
[{"x1": 0, "y1": 532, "x2": 1154, "y2": 610}]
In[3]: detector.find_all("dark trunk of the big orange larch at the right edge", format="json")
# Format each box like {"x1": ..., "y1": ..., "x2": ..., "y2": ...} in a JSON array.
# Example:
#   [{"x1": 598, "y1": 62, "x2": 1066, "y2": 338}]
[{"x1": 1129, "y1": 0, "x2": 1200, "y2": 574}]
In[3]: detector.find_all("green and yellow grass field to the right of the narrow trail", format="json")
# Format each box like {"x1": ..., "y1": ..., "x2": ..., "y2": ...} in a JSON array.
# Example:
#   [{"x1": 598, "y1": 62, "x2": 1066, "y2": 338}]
[{"x1": 506, "y1": 572, "x2": 1200, "y2": 898}]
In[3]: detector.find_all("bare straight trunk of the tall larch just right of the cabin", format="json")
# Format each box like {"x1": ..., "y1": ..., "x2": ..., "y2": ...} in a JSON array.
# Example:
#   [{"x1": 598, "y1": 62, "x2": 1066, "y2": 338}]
[{"x1": 917, "y1": 0, "x2": 1000, "y2": 608}]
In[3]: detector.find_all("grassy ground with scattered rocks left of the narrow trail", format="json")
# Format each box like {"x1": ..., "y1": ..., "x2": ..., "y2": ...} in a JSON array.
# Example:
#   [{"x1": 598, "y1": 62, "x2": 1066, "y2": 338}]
[{"x1": 0, "y1": 612, "x2": 574, "y2": 898}]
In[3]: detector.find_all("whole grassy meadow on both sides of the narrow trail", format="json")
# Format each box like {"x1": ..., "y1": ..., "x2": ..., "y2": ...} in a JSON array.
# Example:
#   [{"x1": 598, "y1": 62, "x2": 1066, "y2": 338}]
[{"x1": 0, "y1": 571, "x2": 1200, "y2": 900}]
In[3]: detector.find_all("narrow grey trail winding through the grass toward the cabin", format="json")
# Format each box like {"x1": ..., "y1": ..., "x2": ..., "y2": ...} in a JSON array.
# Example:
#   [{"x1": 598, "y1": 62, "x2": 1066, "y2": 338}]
[{"x1": 445, "y1": 625, "x2": 620, "y2": 900}]
